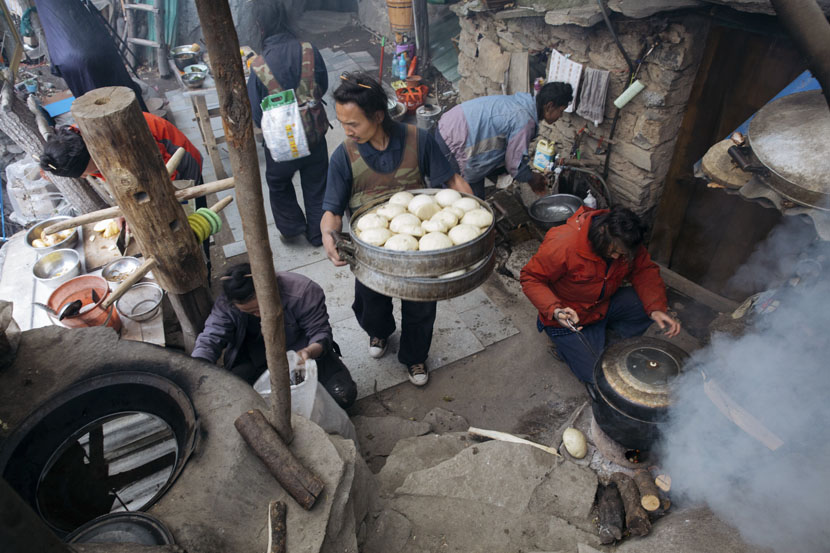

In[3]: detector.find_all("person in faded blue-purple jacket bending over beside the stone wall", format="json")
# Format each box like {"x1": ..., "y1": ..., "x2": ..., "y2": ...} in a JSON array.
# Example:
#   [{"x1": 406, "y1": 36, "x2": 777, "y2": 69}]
[{"x1": 435, "y1": 82, "x2": 573, "y2": 199}]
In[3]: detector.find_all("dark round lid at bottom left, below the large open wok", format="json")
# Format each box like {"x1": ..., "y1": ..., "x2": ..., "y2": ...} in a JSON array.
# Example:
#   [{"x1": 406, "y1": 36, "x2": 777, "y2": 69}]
[{"x1": 65, "y1": 512, "x2": 176, "y2": 545}]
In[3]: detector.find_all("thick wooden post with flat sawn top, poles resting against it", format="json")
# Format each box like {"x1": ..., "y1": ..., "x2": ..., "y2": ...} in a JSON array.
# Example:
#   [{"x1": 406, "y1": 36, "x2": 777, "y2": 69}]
[{"x1": 72, "y1": 86, "x2": 213, "y2": 351}]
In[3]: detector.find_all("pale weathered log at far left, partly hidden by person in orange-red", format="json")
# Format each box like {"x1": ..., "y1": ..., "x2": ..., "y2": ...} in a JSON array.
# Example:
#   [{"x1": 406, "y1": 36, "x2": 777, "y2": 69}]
[{"x1": 0, "y1": 81, "x2": 109, "y2": 213}]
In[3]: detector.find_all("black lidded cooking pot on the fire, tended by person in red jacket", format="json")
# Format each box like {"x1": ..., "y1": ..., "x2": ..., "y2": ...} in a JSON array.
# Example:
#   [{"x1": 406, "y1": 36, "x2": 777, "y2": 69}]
[{"x1": 588, "y1": 337, "x2": 688, "y2": 450}]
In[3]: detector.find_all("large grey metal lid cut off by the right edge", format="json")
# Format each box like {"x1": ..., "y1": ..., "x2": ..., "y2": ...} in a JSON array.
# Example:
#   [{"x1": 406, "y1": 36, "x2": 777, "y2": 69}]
[{"x1": 748, "y1": 90, "x2": 830, "y2": 209}]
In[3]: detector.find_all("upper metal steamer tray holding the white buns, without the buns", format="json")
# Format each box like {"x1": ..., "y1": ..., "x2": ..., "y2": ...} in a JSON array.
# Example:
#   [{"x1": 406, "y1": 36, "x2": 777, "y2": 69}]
[{"x1": 338, "y1": 189, "x2": 496, "y2": 278}]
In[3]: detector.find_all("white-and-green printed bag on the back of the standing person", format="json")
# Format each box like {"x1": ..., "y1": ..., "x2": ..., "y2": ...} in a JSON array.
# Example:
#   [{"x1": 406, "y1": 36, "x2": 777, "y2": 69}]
[{"x1": 261, "y1": 89, "x2": 310, "y2": 161}]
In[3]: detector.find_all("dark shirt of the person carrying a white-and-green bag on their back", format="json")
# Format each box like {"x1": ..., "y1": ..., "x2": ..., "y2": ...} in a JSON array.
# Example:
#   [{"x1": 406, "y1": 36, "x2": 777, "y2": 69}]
[{"x1": 248, "y1": 33, "x2": 329, "y2": 127}]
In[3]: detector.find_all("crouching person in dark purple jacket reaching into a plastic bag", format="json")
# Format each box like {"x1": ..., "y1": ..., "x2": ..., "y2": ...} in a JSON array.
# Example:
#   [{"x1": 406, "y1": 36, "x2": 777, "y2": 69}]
[{"x1": 190, "y1": 263, "x2": 357, "y2": 409}]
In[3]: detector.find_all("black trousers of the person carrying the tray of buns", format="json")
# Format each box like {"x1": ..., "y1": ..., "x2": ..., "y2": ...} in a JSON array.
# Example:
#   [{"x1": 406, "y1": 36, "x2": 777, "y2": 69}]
[{"x1": 352, "y1": 280, "x2": 437, "y2": 365}]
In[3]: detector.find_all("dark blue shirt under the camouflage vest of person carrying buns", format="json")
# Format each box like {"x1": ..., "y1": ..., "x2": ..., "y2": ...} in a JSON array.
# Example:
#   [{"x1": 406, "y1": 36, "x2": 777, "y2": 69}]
[{"x1": 323, "y1": 123, "x2": 455, "y2": 215}]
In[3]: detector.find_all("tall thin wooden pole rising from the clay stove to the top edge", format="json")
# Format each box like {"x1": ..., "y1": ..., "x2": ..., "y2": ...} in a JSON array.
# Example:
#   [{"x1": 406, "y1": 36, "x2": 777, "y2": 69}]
[{"x1": 196, "y1": 0, "x2": 294, "y2": 443}]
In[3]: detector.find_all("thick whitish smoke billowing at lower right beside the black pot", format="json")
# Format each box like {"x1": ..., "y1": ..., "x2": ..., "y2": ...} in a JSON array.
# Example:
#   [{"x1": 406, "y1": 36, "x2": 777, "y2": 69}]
[{"x1": 660, "y1": 268, "x2": 830, "y2": 553}]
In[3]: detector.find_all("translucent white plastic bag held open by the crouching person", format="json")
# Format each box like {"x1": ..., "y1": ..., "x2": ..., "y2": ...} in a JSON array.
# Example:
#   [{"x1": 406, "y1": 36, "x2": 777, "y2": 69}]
[{"x1": 254, "y1": 351, "x2": 357, "y2": 443}]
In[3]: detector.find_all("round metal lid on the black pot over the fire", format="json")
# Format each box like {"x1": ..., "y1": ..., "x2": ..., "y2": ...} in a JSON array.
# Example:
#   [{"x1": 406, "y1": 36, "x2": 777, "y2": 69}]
[{"x1": 601, "y1": 337, "x2": 688, "y2": 409}]
